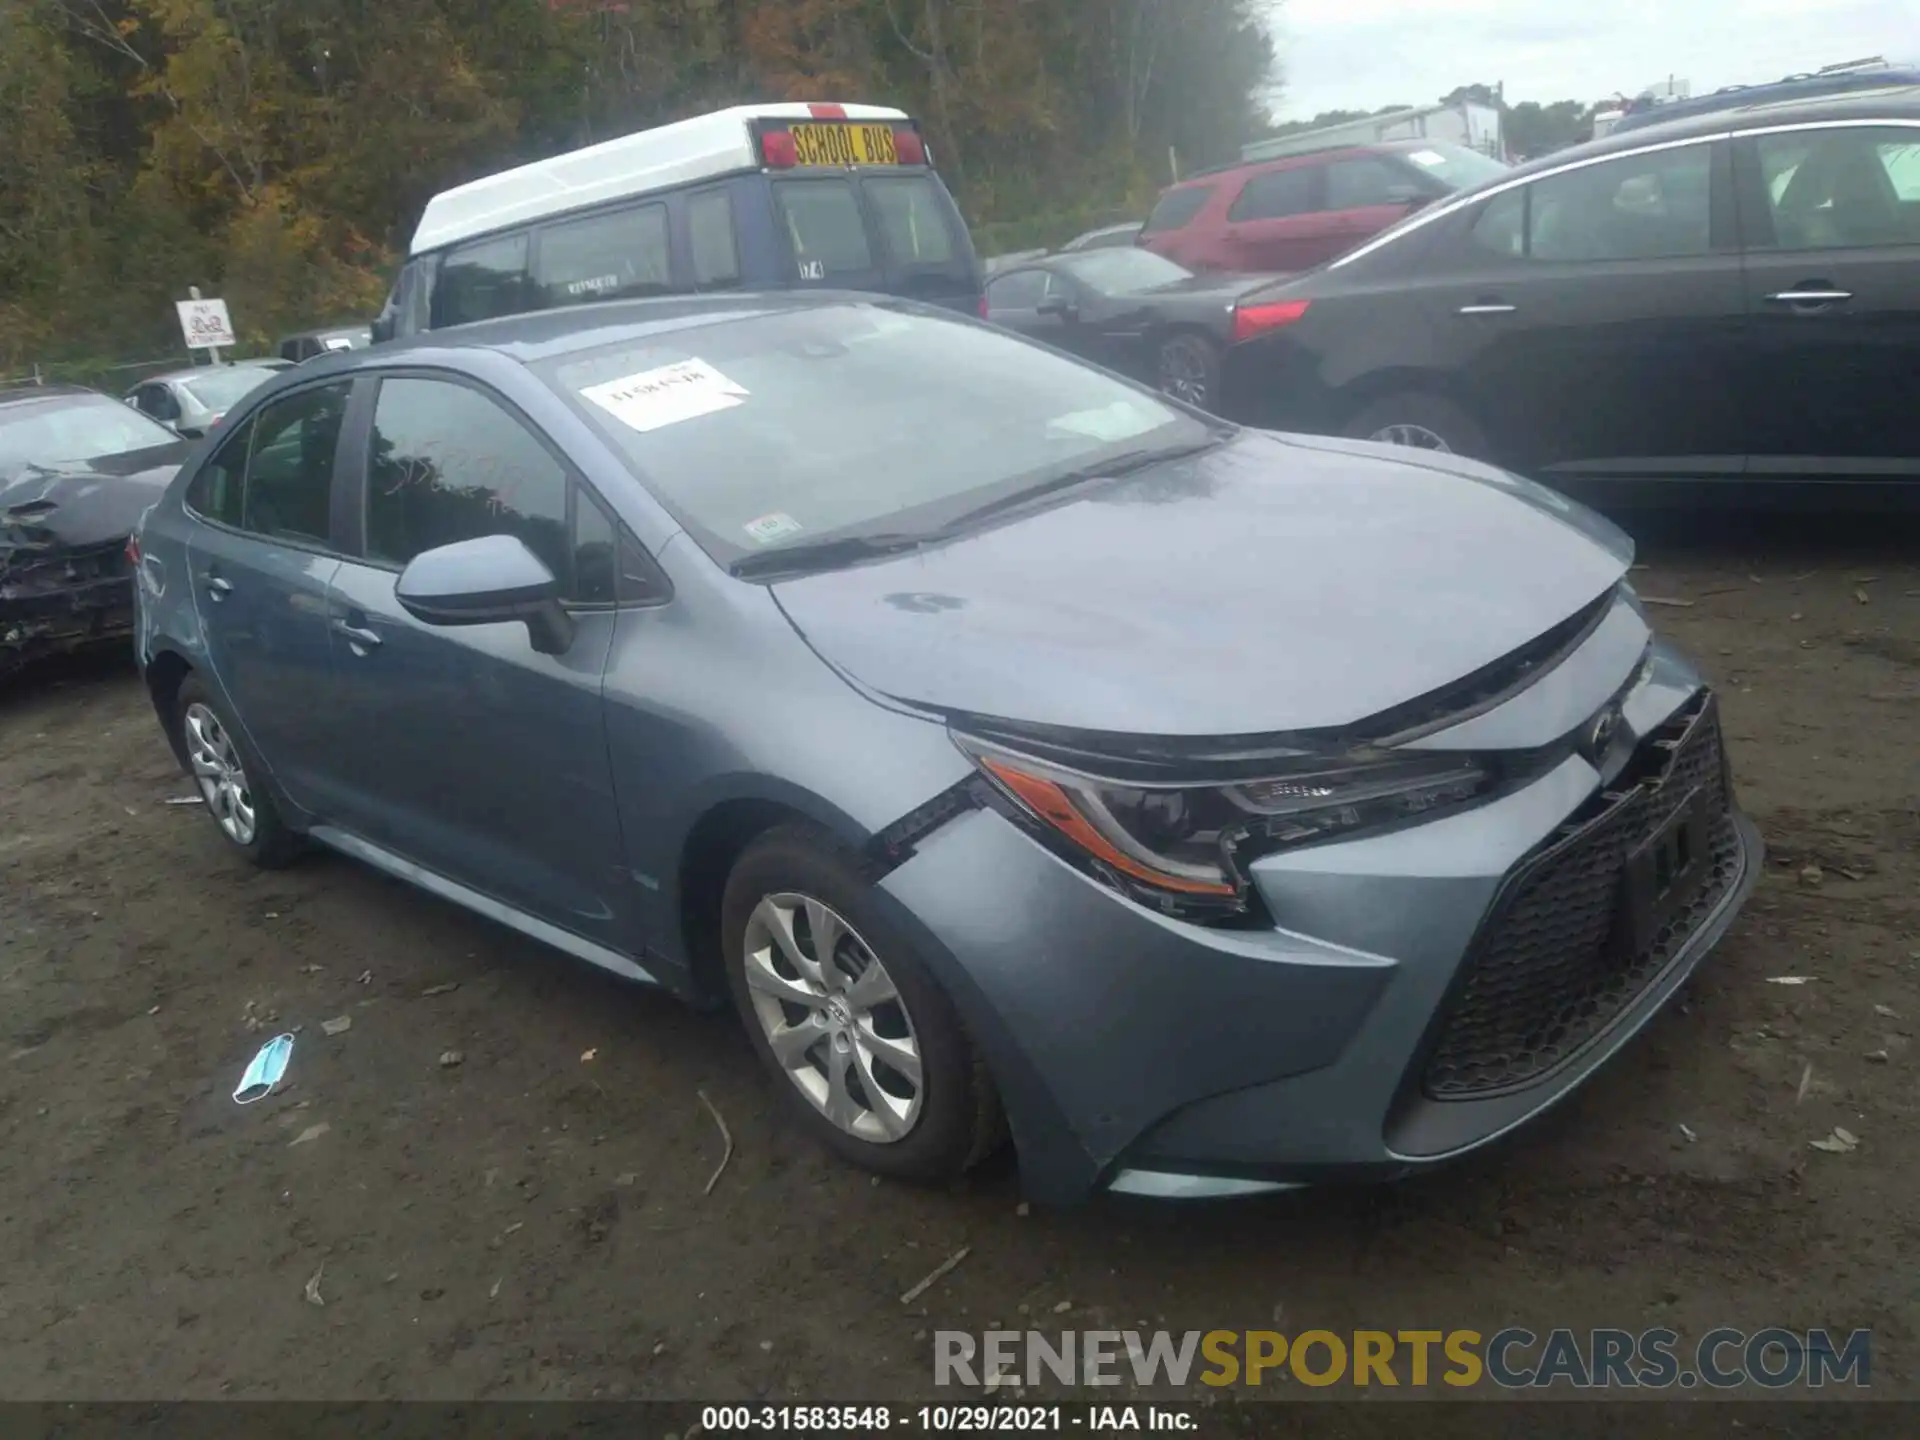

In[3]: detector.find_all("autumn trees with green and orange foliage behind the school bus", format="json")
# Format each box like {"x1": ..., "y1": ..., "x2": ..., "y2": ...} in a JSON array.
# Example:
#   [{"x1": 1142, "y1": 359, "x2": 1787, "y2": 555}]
[{"x1": 0, "y1": 0, "x2": 1273, "y2": 371}]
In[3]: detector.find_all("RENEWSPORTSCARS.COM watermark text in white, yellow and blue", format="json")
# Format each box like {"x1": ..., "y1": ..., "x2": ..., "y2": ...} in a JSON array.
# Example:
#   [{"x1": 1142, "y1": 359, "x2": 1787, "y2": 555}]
[{"x1": 933, "y1": 1327, "x2": 1872, "y2": 1390}]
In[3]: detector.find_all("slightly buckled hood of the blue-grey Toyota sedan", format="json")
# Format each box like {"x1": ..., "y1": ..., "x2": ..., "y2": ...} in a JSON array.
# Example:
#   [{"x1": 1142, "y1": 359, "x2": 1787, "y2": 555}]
[{"x1": 774, "y1": 432, "x2": 1632, "y2": 737}]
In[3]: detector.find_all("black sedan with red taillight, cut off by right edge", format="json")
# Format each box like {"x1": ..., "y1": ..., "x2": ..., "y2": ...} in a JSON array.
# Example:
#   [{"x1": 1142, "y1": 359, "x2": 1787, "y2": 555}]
[{"x1": 1223, "y1": 88, "x2": 1920, "y2": 503}]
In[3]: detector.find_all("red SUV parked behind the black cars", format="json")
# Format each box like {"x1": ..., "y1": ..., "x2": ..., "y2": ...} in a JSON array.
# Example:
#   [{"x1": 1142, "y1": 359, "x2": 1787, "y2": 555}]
[{"x1": 1137, "y1": 140, "x2": 1507, "y2": 271}]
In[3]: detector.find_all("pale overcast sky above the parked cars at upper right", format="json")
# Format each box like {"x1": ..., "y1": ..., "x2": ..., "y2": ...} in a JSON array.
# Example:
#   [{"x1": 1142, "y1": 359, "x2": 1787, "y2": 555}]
[{"x1": 1273, "y1": 0, "x2": 1920, "y2": 119}]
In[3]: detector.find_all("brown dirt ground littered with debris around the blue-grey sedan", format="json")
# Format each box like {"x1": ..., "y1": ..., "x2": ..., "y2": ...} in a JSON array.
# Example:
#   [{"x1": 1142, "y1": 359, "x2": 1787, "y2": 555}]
[{"x1": 0, "y1": 524, "x2": 1920, "y2": 1402}]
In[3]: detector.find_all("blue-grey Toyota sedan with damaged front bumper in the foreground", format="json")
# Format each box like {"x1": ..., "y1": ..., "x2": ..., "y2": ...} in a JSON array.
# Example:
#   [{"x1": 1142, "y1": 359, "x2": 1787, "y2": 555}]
[{"x1": 132, "y1": 292, "x2": 1761, "y2": 1202}]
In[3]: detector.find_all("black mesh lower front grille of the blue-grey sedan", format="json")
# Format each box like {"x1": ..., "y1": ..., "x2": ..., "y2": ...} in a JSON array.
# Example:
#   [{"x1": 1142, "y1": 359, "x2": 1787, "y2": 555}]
[{"x1": 1425, "y1": 693, "x2": 1740, "y2": 1100}]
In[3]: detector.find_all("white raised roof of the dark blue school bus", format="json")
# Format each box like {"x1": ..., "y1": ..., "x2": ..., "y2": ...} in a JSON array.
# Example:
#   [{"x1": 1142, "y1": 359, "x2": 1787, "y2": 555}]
[{"x1": 407, "y1": 104, "x2": 906, "y2": 255}]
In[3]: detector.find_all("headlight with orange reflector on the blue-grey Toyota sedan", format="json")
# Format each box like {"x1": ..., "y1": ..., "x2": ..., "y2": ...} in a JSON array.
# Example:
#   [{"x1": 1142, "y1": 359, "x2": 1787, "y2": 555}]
[{"x1": 954, "y1": 733, "x2": 1492, "y2": 910}]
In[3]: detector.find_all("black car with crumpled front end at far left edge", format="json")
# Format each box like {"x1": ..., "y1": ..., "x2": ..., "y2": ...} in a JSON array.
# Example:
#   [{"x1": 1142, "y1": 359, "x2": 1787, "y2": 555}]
[{"x1": 0, "y1": 386, "x2": 186, "y2": 678}]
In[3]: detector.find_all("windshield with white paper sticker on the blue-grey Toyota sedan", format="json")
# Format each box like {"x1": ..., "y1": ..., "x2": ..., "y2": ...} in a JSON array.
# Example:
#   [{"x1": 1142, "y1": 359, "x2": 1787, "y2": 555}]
[{"x1": 536, "y1": 301, "x2": 1213, "y2": 564}]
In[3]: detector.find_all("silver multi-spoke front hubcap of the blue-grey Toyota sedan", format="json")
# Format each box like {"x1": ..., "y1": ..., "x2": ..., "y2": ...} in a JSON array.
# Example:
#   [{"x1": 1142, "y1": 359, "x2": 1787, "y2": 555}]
[{"x1": 745, "y1": 893, "x2": 925, "y2": 1144}]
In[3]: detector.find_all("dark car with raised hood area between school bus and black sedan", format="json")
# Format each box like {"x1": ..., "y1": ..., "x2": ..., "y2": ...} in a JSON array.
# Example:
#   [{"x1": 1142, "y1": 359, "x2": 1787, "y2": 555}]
[{"x1": 987, "y1": 246, "x2": 1273, "y2": 409}]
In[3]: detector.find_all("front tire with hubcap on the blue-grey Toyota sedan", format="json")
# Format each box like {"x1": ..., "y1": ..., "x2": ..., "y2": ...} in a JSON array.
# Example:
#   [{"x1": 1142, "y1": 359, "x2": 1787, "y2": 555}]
[{"x1": 720, "y1": 826, "x2": 1006, "y2": 1181}]
